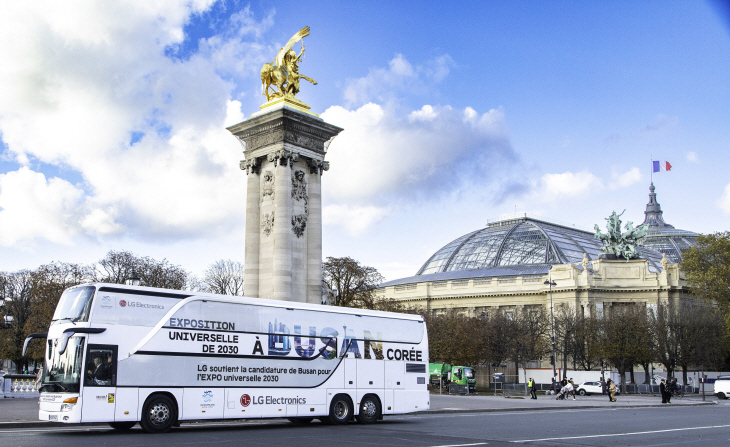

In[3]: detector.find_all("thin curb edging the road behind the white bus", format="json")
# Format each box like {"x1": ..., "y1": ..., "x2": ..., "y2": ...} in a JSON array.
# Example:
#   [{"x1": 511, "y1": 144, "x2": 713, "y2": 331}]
[{"x1": 0, "y1": 402, "x2": 718, "y2": 430}]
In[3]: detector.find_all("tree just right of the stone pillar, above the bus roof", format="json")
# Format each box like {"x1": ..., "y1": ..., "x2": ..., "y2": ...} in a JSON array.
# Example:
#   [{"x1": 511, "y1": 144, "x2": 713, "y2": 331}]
[{"x1": 322, "y1": 256, "x2": 385, "y2": 309}]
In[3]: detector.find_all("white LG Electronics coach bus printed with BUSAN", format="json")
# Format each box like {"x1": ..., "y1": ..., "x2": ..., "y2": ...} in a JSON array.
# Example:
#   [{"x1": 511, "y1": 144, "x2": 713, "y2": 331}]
[{"x1": 24, "y1": 284, "x2": 430, "y2": 432}]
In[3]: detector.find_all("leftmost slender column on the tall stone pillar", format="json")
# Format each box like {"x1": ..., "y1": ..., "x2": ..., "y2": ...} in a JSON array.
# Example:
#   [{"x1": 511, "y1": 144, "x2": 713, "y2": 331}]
[{"x1": 240, "y1": 158, "x2": 261, "y2": 298}]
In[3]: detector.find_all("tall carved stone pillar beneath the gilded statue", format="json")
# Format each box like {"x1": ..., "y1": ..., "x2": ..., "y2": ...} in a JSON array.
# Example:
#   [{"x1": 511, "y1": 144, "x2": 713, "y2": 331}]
[{"x1": 228, "y1": 101, "x2": 342, "y2": 304}]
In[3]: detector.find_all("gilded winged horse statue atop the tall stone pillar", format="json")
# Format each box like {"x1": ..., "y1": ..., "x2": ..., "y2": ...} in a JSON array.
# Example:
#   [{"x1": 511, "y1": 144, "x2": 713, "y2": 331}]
[{"x1": 261, "y1": 26, "x2": 317, "y2": 102}]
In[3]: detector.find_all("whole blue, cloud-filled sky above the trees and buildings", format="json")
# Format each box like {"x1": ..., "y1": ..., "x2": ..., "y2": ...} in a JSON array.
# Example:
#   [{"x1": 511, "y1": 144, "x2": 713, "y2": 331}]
[{"x1": 0, "y1": 0, "x2": 730, "y2": 279}]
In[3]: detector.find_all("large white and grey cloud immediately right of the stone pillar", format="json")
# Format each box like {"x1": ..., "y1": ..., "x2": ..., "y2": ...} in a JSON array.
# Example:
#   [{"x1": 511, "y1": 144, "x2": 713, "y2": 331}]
[{"x1": 322, "y1": 103, "x2": 514, "y2": 201}]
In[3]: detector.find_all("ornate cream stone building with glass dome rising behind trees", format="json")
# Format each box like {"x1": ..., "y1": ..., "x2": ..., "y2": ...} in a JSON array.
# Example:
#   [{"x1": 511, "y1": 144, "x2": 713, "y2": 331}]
[{"x1": 377, "y1": 185, "x2": 696, "y2": 316}]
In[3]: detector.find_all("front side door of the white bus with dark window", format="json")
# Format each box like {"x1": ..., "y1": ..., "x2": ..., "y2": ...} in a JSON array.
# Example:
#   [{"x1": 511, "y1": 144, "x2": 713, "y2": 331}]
[{"x1": 81, "y1": 344, "x2": 117, "y2": 422}]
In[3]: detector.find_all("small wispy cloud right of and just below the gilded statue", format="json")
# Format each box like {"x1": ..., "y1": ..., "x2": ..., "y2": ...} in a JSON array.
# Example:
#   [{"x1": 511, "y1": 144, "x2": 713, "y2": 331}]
[{"x1": 344, "y1": 54, "x2": 455, "y2": 106}]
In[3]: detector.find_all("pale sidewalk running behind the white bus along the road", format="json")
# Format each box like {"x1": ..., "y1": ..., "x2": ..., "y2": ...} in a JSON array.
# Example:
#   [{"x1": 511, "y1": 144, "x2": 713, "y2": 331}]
[{"x1": 0, "y1": 394, "x2": 718, "y2": 430}]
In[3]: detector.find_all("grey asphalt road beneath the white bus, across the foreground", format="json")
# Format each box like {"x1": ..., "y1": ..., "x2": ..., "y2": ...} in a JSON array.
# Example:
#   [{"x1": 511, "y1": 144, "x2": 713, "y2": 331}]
[{"x1": 0, "y1": 403, "x2": 730, "y2": 447}]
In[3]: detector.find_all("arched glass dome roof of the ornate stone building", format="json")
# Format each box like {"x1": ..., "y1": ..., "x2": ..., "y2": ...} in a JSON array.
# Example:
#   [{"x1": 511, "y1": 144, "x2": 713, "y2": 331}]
[{"x1": 417, "y1": 216, "x2": 661, "y2": 275}]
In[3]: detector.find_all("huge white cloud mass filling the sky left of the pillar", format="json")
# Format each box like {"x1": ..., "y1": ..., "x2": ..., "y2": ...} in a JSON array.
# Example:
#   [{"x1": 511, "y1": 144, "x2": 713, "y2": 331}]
[{"x1": 0, "y1": 0, "x2": 272, "y2": 245}]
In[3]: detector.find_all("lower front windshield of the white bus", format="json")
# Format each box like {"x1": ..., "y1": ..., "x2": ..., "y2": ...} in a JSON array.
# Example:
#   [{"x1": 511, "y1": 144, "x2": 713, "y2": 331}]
[{"x1": 43, "y1": 337, "x2": 84, "y2": 393}]
